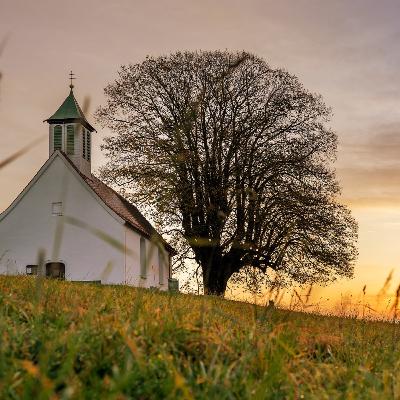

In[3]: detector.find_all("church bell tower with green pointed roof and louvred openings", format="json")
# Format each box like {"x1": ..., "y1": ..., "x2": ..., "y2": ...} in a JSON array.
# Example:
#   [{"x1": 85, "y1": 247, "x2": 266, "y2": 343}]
[{"x1": 45, "y1": 71, "x2": 95, "y2": 176}]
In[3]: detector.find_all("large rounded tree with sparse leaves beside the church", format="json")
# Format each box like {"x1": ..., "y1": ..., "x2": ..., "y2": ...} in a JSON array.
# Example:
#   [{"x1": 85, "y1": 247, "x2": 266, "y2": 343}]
[{"x1": 97, "y1": 51, "x2": 357, "y2": 295}]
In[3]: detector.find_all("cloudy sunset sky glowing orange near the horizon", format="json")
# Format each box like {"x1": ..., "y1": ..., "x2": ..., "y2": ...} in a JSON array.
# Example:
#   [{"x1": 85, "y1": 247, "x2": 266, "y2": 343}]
[{"x1": 0, "y1": 0, "x2": 400, "y2": 310}]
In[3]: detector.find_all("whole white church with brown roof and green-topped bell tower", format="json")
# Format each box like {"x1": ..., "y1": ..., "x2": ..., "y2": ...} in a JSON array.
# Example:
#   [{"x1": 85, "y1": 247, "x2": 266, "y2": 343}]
[{"x1": 0, "y1": 80, "x2": 175, "y2": 290}]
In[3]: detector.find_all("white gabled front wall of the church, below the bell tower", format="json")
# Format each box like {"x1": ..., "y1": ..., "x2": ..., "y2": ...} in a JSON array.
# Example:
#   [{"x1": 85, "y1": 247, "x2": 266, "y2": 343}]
[{"x1": 0, "y1": 156, "x2": 125, "y2": 283}]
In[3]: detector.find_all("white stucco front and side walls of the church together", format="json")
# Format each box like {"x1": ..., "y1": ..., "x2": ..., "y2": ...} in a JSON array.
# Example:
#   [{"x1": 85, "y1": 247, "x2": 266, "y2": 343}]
[{"x1": 0, "y1": 153, "x2": 169, "y2": 290}]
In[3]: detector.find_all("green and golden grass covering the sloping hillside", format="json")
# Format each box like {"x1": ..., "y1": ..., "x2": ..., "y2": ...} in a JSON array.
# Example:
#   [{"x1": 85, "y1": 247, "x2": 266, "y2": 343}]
[{"x1": 0, "y1": 277, "x2": 400, "y2": 399}]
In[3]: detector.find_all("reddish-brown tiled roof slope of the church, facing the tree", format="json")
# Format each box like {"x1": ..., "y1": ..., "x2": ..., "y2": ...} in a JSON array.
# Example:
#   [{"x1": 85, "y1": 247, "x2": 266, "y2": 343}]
[{"x1": 60, "y1": 152, "x2": 176, "y2": 254}]
